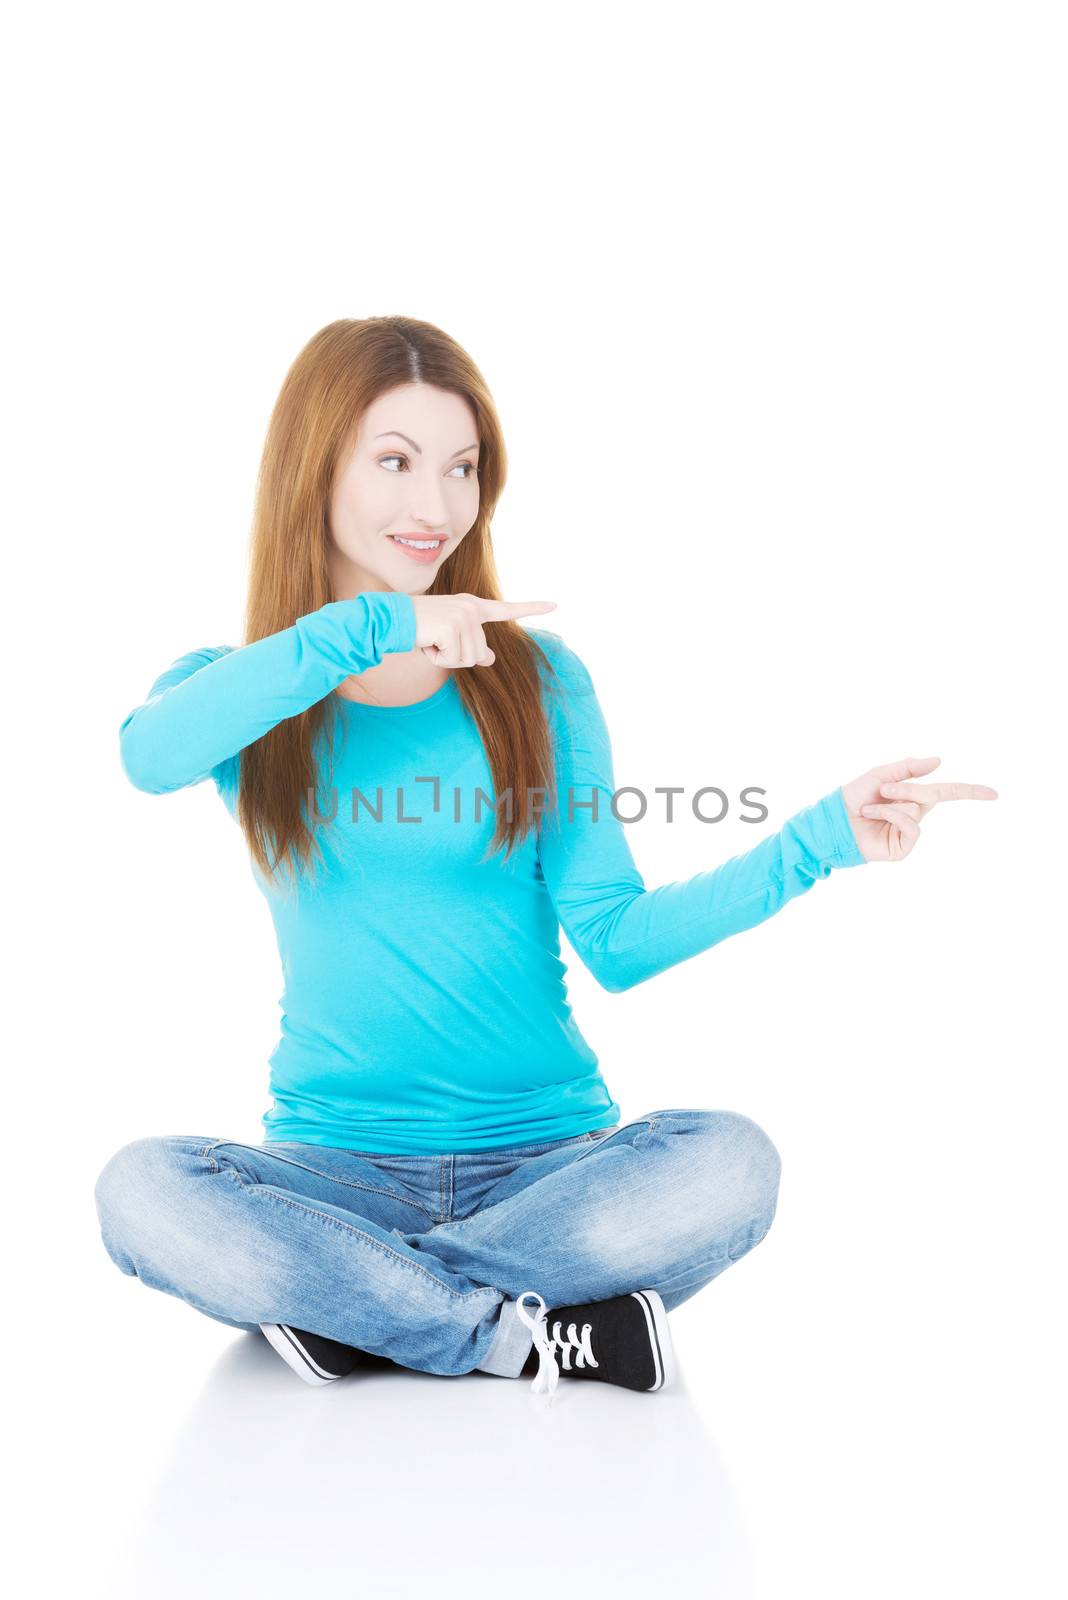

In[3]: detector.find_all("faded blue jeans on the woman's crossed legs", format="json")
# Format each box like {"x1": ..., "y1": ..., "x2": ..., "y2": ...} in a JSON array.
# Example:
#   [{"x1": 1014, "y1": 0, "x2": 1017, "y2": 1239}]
[{"x1": 94, "y1": 1110, "x2": 780, "y2": 1378}]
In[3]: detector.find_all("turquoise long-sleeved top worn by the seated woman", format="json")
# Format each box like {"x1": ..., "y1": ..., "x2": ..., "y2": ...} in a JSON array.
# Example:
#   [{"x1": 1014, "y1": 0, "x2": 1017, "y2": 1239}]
[{"x1": 120, "y1": 592, "x2": 865, "y2": 1155}]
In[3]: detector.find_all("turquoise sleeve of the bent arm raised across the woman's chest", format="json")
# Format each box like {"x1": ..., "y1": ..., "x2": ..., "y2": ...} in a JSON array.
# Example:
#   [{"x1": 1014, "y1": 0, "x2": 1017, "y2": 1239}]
[{"x1": 118, "y1": 590, "x2": 416, "y2": 794}]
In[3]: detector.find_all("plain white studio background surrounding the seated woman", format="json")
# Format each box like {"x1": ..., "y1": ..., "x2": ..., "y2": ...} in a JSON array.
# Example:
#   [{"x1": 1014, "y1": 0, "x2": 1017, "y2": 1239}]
[{"x1": 3, "y1": 0, "x2": 1068, "y2": 1600}]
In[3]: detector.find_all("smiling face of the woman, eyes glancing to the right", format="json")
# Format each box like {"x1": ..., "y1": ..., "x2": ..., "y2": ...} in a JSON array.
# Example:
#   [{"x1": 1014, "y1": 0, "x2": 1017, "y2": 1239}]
[{"x1": 328, "y1": 384, "x2": 480, "y2": 600}]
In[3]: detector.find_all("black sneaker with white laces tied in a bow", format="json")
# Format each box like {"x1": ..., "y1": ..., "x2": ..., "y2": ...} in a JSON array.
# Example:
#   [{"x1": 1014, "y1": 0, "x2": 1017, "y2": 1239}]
[{"x1": 516, "y1": 1290, "x2": 675, "y2": 1397}]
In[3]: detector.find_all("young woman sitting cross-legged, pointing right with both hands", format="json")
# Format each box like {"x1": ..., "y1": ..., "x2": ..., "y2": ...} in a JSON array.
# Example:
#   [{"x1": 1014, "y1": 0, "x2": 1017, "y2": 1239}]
[{"x1": 96, "y1": 317, "x2": 996, "y2": 1397}]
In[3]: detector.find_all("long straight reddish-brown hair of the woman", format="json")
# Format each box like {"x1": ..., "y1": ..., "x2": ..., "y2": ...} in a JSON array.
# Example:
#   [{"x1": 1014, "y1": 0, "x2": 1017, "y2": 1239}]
[{"x1": 237, "y1": 317, "x2": 558, "y2": 877}]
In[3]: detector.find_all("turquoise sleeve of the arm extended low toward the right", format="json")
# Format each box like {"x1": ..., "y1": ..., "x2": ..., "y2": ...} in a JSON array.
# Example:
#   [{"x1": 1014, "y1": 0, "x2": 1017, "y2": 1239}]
[{"x1": 537, "y1": 632, "x2": 865, "y2": 992}]
